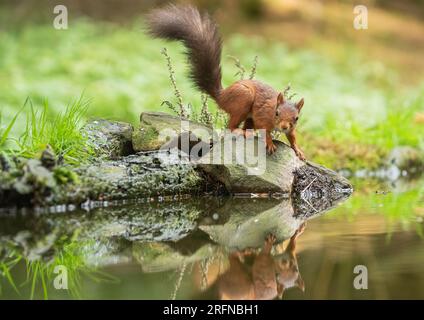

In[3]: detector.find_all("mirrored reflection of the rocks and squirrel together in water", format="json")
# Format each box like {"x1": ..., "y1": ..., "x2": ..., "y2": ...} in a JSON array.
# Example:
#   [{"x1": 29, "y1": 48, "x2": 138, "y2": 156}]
[{"x1": 0, "y1": 186, "x2": 352, "y2": 299}]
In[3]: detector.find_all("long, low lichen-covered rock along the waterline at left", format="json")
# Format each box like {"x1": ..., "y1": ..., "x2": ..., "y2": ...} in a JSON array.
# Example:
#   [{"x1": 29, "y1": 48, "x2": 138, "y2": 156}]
[{"x1": 0, "y1": 149, "x2": 206, "y2": 207}]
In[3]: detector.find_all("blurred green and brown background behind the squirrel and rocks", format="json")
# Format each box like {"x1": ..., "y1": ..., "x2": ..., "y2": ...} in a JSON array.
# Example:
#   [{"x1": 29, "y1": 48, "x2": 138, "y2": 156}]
[{"x1": 0, "y1": 0, "x2": 424, "y2": 170}]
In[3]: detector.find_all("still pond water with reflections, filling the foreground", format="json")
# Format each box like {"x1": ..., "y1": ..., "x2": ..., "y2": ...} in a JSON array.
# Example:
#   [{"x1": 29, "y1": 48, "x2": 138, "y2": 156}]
[{"x1": 0, "y1": 181, "x2": 424, "y2": 299}]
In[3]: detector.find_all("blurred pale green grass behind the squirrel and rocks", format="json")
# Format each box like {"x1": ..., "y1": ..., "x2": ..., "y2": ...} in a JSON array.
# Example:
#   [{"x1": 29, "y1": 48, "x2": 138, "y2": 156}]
[{"x1": 0, "y1": 18, "x2": 424, "y2": 169}]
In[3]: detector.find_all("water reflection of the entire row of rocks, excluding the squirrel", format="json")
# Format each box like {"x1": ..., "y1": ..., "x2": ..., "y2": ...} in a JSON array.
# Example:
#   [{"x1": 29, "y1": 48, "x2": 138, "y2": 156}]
[{"x1": 0, "y1": 192, "x2": 348, "y2": 272}]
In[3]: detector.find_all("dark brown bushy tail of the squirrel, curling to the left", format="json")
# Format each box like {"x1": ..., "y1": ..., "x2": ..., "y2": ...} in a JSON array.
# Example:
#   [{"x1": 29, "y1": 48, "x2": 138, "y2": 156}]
[{"x1": 147, "y1": 5, "x2": 222, "y2": 100}]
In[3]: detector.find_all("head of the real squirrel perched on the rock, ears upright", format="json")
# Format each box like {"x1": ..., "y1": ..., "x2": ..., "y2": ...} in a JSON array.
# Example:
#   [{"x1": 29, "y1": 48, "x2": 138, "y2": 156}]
[{"x1": 274, "y1": 92, "x2": 304, "y2": 133}]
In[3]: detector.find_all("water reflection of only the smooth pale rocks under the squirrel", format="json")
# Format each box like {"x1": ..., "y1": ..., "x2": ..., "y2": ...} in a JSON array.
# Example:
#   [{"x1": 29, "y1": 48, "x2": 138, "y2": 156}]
[{"x1": 134, "y1": 191, "x2": 352, "y2": 272}]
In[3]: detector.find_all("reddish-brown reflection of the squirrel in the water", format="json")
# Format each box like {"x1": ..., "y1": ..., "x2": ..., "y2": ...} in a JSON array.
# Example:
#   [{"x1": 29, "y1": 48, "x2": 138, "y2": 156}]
[{"x1": 216, "y1": 223, "x2": 306, "y2": 300}]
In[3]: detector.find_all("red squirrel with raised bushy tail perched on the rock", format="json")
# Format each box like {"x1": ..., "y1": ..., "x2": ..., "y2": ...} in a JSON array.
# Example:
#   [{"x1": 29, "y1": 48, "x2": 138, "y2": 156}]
[{"x1": 147, "y1": 5, "x2": 305, "y2": 160}]
